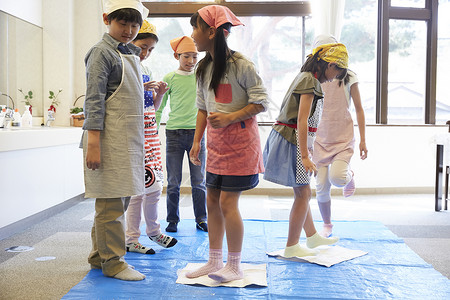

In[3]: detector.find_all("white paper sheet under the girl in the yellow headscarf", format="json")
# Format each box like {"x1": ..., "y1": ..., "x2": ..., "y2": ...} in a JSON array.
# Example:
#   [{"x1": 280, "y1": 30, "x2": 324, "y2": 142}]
[{"x1": 267, "y1": 246, "x2": 368, "y2": 267}]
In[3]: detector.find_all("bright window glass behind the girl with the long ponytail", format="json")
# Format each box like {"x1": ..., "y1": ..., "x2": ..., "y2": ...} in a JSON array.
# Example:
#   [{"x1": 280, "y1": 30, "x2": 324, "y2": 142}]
[{"x1": 144, "y1": 2, "x2": 313, "y2": 123}]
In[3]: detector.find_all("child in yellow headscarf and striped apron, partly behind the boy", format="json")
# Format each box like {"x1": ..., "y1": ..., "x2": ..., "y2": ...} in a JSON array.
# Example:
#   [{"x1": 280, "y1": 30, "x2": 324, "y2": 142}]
[{"x1": 126, "y1": 20, "x2": 177, "y2": 254}]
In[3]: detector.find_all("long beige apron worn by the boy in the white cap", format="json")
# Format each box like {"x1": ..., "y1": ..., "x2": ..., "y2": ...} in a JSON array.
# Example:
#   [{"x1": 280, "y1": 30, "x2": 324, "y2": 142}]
[{"x1": 83, "y1": 53, "x2": 145, "y2": 198}]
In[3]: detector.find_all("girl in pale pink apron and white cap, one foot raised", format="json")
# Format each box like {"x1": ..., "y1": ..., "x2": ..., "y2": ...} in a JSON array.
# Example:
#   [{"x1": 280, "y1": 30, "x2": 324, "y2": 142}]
[{"x1": 313, "y1": 35, "x2": 367, "y2": 237}]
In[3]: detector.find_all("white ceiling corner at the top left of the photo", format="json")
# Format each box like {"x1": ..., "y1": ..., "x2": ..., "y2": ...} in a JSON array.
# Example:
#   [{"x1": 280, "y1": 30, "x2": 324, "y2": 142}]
[{"x1": 0, "y1": 0, "x2": 42, "y2": 27}]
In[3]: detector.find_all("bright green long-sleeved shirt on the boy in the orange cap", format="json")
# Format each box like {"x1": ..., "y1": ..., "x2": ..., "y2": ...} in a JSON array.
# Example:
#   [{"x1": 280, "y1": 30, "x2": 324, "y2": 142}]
[{"x1": 156, "y1": 70, "x2": 198, "y2": 130}]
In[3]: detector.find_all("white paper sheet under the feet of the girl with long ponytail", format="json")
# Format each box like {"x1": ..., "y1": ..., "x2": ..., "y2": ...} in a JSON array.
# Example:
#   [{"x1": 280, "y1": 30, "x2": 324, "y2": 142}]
[{"x1": 176, "y1": 263, "x2": 267, "y2": 287}]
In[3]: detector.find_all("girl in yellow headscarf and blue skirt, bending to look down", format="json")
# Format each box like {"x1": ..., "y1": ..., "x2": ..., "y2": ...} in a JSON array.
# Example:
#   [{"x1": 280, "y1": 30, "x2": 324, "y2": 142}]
[{"x1": 264, "y1": 43, "x2": 348, "y2": 257}]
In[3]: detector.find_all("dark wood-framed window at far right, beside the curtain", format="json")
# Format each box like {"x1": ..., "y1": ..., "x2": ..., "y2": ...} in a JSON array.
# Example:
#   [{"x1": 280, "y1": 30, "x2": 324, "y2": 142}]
[{"x1": 376, "y1": 0, "x2": 438, "y2": 124}]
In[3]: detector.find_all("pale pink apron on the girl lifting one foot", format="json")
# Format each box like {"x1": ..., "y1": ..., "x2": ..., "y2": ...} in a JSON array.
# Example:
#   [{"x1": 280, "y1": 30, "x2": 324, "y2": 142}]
[{"x1": 313, "y1": 81, "x2": 355, "y2": 168}]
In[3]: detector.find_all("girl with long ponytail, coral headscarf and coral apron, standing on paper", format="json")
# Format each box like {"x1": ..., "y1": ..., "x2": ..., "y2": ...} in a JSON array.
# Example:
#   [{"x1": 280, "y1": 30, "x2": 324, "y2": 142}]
[{"x1": 186, "y1": 5, "x2": 268, "y2": 282}]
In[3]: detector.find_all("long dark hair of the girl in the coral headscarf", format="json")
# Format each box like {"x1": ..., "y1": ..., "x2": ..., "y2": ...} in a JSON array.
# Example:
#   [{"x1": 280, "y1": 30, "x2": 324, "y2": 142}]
[{"x1": 190, "y1": 12, "x2": 231, "y2": 92}]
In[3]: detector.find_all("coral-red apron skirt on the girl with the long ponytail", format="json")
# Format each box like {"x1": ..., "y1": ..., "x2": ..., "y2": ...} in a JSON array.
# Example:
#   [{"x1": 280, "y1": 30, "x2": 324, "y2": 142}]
[{"x1": 206, "y1": 116, "x2": 264, "y2": 176}]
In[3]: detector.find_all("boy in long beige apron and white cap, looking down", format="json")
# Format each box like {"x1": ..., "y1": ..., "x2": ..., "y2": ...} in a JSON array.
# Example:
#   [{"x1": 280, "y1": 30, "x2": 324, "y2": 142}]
[{"x1": 82, "y1": 0, "x2": 148, "y2": 280}]
